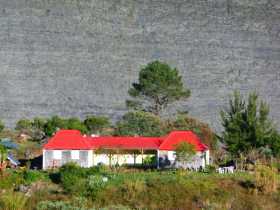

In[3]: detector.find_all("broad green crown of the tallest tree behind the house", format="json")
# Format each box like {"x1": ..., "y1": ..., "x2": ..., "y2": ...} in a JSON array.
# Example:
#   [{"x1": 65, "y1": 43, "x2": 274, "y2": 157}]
[{"x1": 127, "y1": 61, "x2": 190, "y2": 115}]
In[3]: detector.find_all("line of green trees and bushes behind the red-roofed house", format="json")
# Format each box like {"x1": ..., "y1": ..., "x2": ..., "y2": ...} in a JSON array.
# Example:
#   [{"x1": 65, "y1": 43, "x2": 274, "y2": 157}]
[{"x1": 0, "y1": 61, "x2": 280, "y2": 162}]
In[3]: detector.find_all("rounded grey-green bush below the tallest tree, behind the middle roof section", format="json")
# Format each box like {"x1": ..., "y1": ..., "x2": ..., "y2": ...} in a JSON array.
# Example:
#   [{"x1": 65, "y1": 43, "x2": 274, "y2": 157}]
[{"x1": 115, "y1": 111, "x2": 162, "y2": 136}]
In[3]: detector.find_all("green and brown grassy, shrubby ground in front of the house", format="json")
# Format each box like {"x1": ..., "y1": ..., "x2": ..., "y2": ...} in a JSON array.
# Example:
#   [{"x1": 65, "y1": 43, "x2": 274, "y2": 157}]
[{"x1": 0, "y1": 166, "x2": 280, "y2": 210}]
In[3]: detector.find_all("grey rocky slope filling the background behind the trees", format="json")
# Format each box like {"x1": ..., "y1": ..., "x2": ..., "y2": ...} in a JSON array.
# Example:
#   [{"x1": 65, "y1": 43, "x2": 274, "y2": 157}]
[{"x1": 0, "y1": 0, "x2": 280, "y2": 130}]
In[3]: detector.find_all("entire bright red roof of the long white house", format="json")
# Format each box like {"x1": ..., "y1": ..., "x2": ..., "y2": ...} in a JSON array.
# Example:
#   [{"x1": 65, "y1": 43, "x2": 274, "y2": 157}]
[{"x1": 44, "y1": 130, "x2": 207, "y2": 151}]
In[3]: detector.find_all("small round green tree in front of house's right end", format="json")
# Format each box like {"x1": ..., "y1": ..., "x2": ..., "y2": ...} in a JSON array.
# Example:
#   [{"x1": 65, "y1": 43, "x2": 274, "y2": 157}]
[{"x1": 175, "y1": 142, "x2": 195, "y2": 166}]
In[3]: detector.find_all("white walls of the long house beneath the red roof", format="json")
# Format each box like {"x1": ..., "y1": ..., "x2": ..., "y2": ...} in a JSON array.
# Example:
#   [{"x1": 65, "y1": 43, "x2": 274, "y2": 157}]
[{"x1": 43, "y1": 150, "x2": 210, "y2": 169}]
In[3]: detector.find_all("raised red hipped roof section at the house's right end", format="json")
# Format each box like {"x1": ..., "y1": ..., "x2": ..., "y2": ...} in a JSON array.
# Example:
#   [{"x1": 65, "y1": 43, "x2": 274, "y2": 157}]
[{"x1": 159, "y1": 131, "x2": 208, "y2": 151}]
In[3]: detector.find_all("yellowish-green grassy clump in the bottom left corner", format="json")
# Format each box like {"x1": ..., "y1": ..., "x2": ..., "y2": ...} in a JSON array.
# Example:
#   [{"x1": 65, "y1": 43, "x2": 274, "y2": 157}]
[{"x1": 0, "y1": 191, "x2": 28, "y2": 210}]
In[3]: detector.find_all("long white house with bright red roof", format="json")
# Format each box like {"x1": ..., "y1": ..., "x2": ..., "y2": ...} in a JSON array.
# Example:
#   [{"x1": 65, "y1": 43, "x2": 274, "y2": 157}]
[{"x1": 43, "y1": 130, "x2": 209, "y2": 169}]
